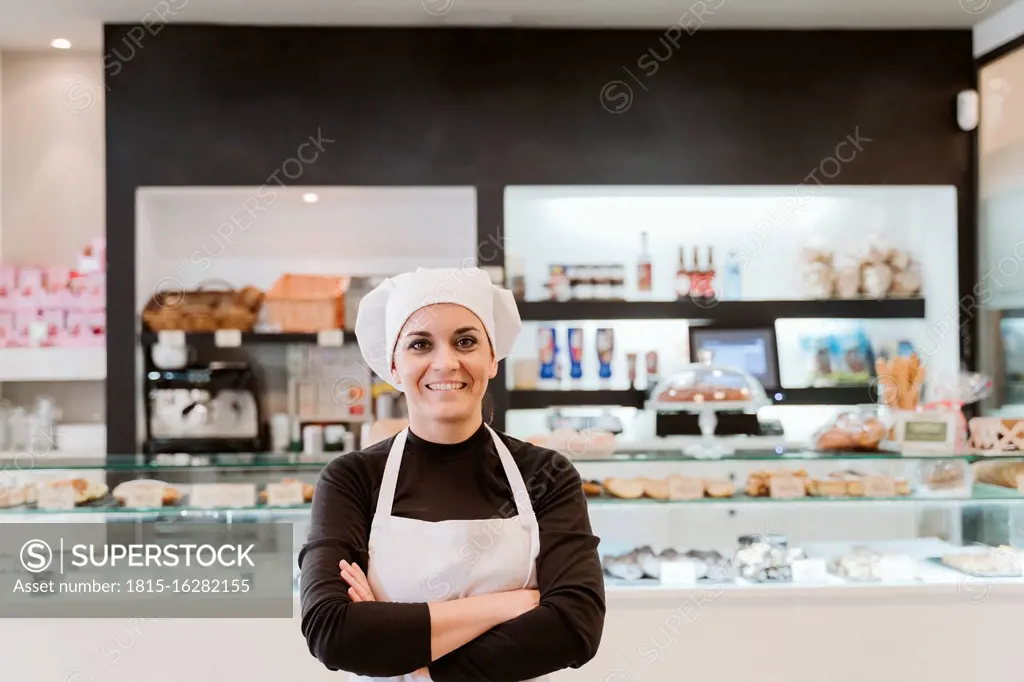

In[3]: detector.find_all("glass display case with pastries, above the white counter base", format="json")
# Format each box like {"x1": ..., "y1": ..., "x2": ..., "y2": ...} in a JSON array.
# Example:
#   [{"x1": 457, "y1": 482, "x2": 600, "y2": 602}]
[{"x1": 0, "y1": 449, "x2": 1024, "y2": 592}]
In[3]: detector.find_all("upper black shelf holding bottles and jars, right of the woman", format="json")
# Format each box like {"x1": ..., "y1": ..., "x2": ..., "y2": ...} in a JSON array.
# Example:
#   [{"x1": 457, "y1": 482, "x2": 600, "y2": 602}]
[{"x1": 519, "y1": 298, "x2": 925, "y2": 326}]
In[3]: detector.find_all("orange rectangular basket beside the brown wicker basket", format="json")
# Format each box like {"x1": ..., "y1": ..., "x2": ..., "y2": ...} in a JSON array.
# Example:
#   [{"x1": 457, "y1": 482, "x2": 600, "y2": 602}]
[{"x1": 265, "y1": 273, "x2": 350, "y2": 332}]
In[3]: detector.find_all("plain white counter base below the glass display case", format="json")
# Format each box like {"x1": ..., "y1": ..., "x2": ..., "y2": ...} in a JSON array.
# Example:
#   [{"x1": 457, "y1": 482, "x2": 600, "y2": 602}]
[{"x1": 0, "y1": 573, "x2": 1024, "y2": 682}]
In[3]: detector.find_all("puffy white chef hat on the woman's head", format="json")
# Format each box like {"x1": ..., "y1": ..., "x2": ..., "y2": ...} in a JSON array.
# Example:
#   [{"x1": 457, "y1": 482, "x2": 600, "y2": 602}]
[{"x1": 355, "y1": 267, "x2": 522, "y2": 390}]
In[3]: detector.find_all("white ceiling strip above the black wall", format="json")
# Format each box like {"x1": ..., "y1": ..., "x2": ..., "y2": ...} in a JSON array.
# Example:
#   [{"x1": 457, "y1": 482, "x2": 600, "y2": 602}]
[{"x1": 0, "y1": 0, "x2": 1013, "y2": 50}]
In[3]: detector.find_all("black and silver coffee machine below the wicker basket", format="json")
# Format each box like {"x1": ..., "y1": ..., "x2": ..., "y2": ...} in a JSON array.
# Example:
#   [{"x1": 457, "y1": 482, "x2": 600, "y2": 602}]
[{"x1": 144, "y1": 363, "x2": 266, "y2": 454}]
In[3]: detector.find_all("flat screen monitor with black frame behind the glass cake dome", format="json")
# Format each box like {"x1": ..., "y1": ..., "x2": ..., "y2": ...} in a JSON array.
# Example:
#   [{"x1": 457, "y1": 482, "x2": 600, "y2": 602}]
[{"x1": 690, "y1": 326, "x2": 779, "y2": 391}]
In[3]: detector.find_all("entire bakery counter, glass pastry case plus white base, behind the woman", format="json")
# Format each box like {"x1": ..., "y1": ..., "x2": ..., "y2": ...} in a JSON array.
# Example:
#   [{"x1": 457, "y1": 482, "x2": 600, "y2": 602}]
[{"x1": 0, "y1": 451, "x2": 1024, "y2": 682}]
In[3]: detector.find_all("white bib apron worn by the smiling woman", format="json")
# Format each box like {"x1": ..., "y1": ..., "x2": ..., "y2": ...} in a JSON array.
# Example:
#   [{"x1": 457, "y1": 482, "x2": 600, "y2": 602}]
[{"x1": 349, "y1": 426, "x2": 546, "y2": 682}]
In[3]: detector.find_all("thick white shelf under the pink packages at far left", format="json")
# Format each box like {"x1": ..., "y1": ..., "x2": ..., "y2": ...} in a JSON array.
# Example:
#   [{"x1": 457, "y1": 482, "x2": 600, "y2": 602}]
[{"x1": 0, "y1": 346, "x2": 106, "y2": 381}]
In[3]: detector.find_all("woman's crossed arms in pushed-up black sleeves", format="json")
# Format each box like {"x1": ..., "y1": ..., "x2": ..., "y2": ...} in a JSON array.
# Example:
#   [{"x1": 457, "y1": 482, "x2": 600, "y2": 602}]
[{"x1": 299, "y1": 448, "x2": 604, "y2": 682}]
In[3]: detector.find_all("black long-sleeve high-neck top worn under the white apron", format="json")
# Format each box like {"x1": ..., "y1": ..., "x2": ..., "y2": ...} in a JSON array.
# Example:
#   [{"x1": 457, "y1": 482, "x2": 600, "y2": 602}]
[{"x1": 299, "y1": 426, "x2": 605, "y2": 682}]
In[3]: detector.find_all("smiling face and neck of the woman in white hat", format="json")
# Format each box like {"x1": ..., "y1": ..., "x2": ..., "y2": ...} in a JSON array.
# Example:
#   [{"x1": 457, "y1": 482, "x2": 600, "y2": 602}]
[{"x1": 391, "y1": 303, "x2": 498, "y2": 433}]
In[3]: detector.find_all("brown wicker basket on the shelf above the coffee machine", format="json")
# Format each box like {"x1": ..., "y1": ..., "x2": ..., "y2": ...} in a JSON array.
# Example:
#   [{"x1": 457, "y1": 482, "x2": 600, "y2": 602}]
[{"x1": 142, "y1": 283, "x2": 263, "y2": 332}]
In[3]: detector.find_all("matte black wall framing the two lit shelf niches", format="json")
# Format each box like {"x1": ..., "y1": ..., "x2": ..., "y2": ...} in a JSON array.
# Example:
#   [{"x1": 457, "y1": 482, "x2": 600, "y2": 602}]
[{"x1": 105, "y1": 26, "x2": 976, "y2": 453}]
